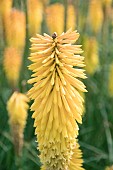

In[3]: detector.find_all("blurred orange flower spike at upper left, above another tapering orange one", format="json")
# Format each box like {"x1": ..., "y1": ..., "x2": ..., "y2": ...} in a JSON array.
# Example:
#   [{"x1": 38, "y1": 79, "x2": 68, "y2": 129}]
[{"x1": 5, "y1": 9, "x2": 26, "y2": 51}]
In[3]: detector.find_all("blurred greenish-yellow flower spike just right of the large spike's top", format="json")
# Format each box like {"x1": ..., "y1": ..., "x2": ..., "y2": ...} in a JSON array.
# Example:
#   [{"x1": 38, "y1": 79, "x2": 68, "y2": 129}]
[{"x1": 83, "y1": 37, "x2": 99, "y2": 74}]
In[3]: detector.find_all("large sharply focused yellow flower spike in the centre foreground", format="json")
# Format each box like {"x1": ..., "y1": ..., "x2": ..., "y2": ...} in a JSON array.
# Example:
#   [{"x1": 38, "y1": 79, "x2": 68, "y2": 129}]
[{"x1": 28, "y1": 30, "x2": 86, "y2": 170}]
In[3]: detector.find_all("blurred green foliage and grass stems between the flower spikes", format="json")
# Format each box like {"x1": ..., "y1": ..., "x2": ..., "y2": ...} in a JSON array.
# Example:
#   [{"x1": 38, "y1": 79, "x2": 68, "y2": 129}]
[{"x1": 0, "y1": 0, "x2": 113, "y2": 170}]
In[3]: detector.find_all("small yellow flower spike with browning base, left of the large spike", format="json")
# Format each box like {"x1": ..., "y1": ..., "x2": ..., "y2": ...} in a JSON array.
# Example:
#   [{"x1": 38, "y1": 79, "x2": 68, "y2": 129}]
[{"x1": 7, "y1": 91, "x2": 29, "y2": 155}]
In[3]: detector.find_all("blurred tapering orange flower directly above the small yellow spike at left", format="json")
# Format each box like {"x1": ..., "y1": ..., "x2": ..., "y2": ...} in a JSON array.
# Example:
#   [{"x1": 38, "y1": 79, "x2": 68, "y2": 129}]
[{"x1": 3, "y1": 47, "x2": 22, "y2": 87}]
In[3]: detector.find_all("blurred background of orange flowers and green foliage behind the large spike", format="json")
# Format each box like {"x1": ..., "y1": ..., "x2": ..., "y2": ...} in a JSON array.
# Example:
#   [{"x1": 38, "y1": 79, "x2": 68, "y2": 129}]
[{"x1": 0, "y1": 0, "x2": 113, "y2": 170}]
